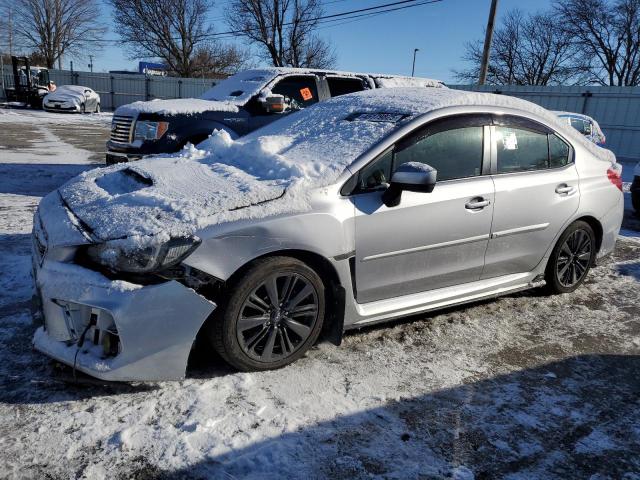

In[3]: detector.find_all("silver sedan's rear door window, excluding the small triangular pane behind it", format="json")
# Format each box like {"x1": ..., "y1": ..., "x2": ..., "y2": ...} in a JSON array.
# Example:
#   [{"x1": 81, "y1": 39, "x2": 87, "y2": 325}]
[{"x1": 495, "y1": 126, "x2": 549, "y2": 173}]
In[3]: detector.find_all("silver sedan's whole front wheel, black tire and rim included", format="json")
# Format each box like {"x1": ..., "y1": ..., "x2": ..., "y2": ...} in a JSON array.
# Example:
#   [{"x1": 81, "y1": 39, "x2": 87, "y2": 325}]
[{"x1": 208, "y1": 257, "x2": 326, "y2": 371}]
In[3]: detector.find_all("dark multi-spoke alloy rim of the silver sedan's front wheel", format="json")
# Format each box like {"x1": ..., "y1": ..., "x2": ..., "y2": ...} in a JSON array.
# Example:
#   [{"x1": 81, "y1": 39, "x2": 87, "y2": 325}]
[{"x1": 236, "y1": 273, "x2": 318, "y2": 362}]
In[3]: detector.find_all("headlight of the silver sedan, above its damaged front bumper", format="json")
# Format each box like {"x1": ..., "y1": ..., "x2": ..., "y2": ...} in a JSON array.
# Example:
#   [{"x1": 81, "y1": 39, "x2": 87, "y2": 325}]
[{"x1": 85, "y1": 237, "x2": 201, "y2": 273}]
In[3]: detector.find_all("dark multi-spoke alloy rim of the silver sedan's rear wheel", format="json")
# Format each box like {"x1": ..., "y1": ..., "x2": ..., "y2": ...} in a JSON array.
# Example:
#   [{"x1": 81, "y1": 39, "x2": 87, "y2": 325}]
[{"x1": 556, "y1": 229, "x2": 593, "y2": 288}]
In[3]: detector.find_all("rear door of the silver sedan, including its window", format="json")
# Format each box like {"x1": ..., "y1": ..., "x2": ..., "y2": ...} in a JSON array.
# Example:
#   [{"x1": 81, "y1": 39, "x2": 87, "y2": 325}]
[{"x1": 482, "y1": 116, "x2": 580, "y2": 278}]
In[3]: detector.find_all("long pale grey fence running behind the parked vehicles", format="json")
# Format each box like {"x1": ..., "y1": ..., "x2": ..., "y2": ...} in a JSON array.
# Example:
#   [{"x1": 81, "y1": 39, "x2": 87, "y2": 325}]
[{"x1": 0, "y1": 65, "x2": 640, "y2": 161}]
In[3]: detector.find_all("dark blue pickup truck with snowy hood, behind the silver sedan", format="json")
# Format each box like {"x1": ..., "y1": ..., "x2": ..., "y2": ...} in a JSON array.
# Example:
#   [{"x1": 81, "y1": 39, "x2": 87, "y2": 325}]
[{"x1": 107, "y1": 68, "x2": 444, "y2": 164}]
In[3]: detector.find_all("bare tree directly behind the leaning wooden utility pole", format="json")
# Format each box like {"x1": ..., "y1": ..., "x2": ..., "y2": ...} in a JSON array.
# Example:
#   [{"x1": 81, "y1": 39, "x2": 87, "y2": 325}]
[{"x1": 454, "y1": 9, "x2": 581, "y2": 85}]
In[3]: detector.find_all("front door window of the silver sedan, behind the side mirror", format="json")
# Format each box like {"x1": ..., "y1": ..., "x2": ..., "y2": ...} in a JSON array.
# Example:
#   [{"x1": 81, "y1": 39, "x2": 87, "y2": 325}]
[{"x1": 394, "y1": 126, "x2": 483, "y2": 181}]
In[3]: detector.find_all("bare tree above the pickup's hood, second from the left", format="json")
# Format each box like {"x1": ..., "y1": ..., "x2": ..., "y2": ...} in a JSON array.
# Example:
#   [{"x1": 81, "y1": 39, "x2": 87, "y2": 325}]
[{"x1": 109, "y1": 0, "x2": 247, "y2": 77}]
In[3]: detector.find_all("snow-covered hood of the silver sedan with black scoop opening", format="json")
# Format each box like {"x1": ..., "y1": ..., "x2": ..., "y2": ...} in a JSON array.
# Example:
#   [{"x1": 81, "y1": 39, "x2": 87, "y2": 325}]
[{"x1": 60, "y1": 157, "x2": 284, "y2": 240}]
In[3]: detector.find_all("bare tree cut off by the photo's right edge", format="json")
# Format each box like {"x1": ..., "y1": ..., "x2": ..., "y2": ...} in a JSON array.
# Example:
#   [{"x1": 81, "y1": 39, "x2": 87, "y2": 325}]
[{"x1": 554, "y1": 0, "x2": 640, "y2": 86}]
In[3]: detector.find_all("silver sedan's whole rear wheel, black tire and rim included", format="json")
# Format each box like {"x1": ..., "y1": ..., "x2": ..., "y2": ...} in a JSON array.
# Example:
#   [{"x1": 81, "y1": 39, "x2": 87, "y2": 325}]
[{"x1": 545, "y1": 220, "x2": 597, "y2": 294}]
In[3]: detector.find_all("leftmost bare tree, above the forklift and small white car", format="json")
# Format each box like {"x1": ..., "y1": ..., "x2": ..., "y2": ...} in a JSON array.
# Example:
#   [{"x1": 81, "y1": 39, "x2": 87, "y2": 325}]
[{"x1": 2, "y1": 0, "x2": 107, "y2": 68}]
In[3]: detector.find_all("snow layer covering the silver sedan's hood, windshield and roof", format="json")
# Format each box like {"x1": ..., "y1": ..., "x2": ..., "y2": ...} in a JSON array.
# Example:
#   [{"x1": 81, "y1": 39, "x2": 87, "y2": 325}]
[{"x1": 59, "y1": 88, "x2": 615, "y2": 240}]
